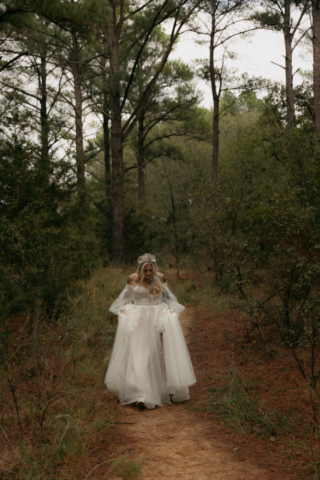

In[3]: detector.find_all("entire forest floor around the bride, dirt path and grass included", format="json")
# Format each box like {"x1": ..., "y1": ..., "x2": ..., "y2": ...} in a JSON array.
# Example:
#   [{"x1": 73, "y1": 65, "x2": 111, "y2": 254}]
[{"x1": 0, "y1": 268, "x2": 320, "y2": 480}]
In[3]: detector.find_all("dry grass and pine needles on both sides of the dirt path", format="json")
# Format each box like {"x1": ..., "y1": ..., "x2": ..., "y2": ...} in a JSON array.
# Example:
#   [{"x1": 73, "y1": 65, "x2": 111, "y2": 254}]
[{"x1": 0, "y1": 268, "x2": 319, "y2": 480}]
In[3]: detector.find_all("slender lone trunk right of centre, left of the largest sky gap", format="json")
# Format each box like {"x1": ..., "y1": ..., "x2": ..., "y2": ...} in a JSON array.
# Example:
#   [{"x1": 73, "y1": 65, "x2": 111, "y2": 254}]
[{"x1": 209, "y1": 0, "x2": 220, "y2": 188}]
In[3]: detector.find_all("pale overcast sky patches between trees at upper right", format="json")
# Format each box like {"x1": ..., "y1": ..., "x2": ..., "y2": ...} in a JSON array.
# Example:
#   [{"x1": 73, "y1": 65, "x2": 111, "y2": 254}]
[{"x1": 171, "y1": 26, "x2": 312, "y2": 108}]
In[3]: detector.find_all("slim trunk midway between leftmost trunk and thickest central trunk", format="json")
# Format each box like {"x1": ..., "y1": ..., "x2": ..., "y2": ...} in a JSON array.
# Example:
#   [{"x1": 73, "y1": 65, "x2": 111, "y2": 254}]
[{"x1": 71, "y1": 32, "x2": 85, "y2": 204}]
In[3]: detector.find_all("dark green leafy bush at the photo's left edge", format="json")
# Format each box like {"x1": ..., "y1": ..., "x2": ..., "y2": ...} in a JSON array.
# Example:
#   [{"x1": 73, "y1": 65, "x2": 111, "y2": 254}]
[{"x1": 0, "y1": 138, "x2": 97, "y2": 315}]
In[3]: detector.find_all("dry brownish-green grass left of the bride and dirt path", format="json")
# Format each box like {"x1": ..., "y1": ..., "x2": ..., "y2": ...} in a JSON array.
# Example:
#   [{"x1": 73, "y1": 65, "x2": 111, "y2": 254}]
[{"x1": 0, "y1": 268, "x2": 140, "y2": 480}]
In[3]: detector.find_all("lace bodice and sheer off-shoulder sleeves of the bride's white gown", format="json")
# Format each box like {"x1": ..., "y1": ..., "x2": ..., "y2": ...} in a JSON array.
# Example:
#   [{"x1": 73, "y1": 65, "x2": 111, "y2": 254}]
[{"x1": 110, "y1": 282, "x2": 184, "y2": 315}]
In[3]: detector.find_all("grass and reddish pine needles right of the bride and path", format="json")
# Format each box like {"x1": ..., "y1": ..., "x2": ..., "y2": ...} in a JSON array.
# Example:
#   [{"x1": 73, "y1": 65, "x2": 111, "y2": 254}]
[{"x1": 162, "y1": 269, "x2": 320, "y2": 480}]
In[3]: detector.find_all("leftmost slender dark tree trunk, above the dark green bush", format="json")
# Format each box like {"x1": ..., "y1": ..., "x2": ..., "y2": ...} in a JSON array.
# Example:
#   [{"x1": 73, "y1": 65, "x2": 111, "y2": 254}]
[{"x1": 39, "y1": 49, "x2": 50, "y2": 186}]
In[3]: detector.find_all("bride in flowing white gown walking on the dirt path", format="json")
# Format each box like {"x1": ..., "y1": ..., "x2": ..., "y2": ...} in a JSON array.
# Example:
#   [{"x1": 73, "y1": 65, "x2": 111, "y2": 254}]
[{"x1": 105, "y1": 253, "x2": 196, "y2": 408}]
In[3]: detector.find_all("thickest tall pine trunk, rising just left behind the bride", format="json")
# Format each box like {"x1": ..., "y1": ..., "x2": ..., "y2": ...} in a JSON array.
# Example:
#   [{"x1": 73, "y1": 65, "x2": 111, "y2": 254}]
[{"x1": 109, "y1": 14, "x2": 124, "y2": 263}]
